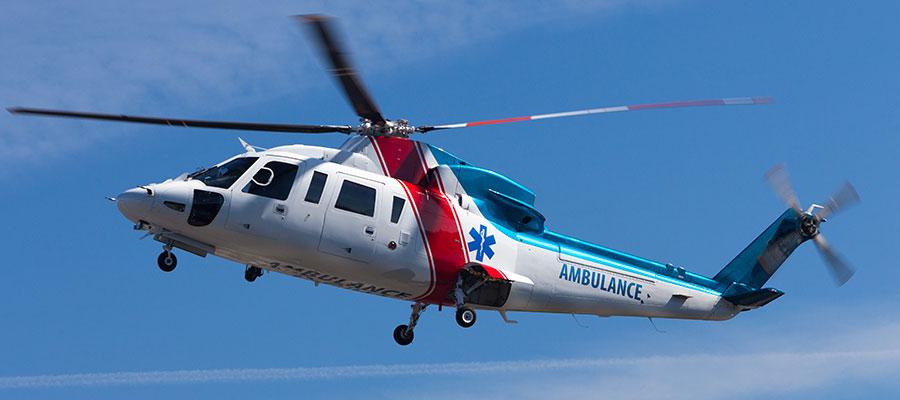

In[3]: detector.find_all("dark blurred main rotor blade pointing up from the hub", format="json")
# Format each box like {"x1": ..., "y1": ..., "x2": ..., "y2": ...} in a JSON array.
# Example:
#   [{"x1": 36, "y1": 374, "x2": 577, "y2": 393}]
[{"x1": 296, "y1": 14, "x2": 385, "y2": 124}]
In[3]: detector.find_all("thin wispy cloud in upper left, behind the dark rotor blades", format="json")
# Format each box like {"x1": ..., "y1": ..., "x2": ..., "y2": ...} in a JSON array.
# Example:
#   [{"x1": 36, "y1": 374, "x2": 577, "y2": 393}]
[{"x1": 0, "y1": 0, "x2": 669, "y2": 167}]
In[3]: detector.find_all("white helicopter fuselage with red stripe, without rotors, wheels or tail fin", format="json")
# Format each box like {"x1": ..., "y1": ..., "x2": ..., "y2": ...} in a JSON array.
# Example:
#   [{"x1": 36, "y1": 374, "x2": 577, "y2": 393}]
[{"x1": 117, "y1": 137, "x2": 740, "y2": 320}]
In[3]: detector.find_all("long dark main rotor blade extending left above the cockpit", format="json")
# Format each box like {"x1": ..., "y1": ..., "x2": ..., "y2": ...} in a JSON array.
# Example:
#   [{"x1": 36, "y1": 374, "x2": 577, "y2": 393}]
[{"x1": 6, "y1": 107, "x2": 353, "y2": 133}]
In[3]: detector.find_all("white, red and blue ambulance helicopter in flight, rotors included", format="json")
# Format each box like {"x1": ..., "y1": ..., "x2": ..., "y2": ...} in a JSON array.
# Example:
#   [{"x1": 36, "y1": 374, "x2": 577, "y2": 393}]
[{"x1": 7, "y1": 15, "x2": 859, "y2": 346}]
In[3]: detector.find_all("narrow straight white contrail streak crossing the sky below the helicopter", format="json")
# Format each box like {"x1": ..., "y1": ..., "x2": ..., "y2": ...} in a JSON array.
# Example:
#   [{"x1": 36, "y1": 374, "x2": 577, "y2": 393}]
[{"x1": 0, "y1": 350, "x2": 900, "y2": 389}]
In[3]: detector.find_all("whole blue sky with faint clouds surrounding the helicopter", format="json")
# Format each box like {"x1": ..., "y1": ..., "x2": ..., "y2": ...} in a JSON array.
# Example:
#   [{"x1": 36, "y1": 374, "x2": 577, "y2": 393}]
[{"x1": 0, "y1": 1, "x2": 900, "y2": 399}]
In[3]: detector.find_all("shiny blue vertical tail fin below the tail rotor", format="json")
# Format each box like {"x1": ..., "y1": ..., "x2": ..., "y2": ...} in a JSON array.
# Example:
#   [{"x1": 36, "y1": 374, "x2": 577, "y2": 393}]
[{"x1": 713, "y1": 208, "x2": 810, "y2": 292}]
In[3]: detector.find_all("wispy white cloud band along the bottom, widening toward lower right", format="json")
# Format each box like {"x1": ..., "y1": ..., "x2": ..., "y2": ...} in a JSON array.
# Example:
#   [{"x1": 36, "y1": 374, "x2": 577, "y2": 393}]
[{"x1": 0, "y1": 322, "x2": 900, "y2": 400}]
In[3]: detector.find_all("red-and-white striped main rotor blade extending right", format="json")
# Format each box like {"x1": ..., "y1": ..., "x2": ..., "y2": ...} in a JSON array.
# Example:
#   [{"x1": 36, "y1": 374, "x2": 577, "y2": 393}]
[{"x1": 417, "y1": 97, "x2": 772, "y2": 132}]
